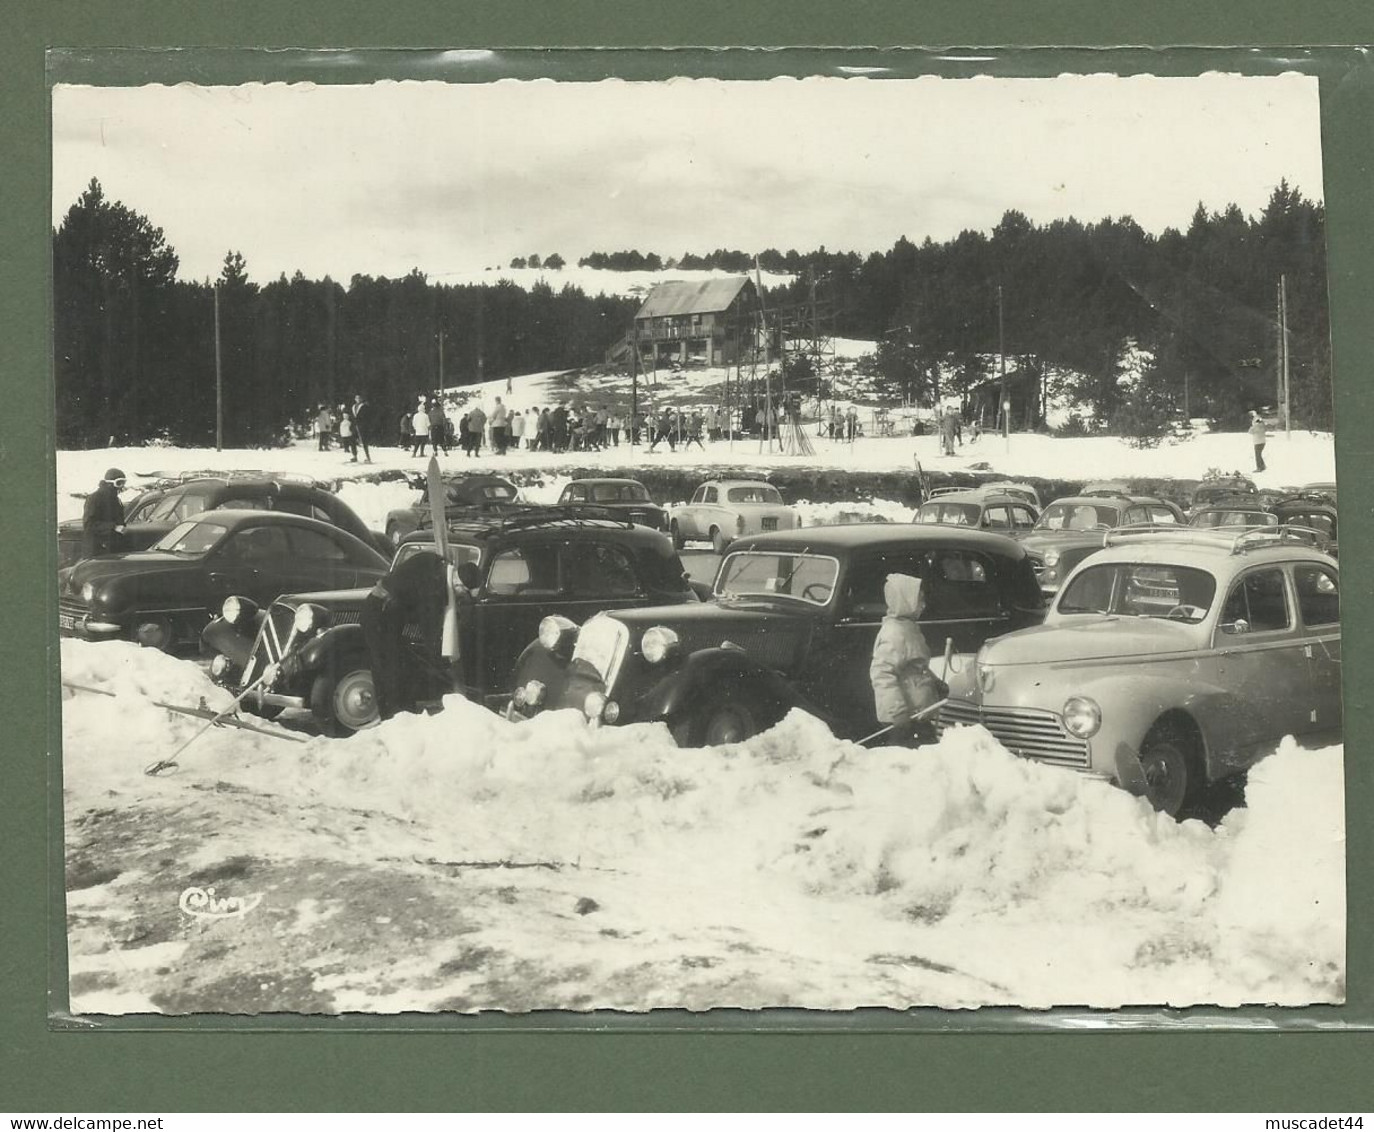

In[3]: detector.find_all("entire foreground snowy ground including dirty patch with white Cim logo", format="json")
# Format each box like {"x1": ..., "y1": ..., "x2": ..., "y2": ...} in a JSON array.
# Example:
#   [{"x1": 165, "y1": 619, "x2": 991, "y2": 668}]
[{"x1": 62, "y1": 642, "x2": 1345, "y2": 1012}]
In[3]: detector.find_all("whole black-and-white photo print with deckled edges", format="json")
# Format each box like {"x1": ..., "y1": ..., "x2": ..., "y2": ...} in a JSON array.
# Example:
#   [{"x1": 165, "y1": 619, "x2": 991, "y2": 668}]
[{"x1": 51, "y1": 66, "x2": 1349, "y2": 1011}]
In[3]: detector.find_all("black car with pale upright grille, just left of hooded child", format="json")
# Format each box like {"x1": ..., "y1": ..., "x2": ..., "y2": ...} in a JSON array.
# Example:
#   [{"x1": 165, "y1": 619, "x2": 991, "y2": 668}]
[{"x1": 514, "y1": 523, "x2": 1044, "y2": 746}]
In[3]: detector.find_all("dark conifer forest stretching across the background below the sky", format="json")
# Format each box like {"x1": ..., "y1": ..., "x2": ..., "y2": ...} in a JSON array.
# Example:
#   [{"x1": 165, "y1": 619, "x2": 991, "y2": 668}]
[{"x1": 54, "y1": 180, "x2": 1331, "y2": 446}]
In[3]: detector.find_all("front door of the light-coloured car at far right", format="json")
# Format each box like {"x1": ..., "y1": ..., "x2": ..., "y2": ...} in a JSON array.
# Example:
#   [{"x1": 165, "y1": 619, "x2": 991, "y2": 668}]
[{"x1": 1213, "y1": 563, "x2": 1315, "y2": 765}]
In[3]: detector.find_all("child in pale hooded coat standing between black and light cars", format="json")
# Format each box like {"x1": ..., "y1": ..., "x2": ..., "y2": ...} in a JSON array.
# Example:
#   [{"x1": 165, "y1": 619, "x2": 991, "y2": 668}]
[{"x1": 868, "y1": 574, "x2": 949, "y2": 746}]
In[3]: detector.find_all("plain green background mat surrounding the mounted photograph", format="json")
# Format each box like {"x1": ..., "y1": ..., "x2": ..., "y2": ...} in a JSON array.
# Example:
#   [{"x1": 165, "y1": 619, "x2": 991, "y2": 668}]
[{"x1": 8, "y1": 0, "x2": 1374, "y2": 1113}]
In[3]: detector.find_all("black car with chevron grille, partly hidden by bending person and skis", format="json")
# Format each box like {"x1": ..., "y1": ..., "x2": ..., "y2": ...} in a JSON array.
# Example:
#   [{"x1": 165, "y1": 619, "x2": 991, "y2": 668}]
[{"x1": 205, "y1": 507, "x2": 697, "y2": 734}]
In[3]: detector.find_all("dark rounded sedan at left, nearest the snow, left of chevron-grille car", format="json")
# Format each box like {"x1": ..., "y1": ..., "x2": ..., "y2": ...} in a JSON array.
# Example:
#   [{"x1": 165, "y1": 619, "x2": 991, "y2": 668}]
[{"x1": 58, "y1": 508, "x2": 387, "y2": 648}]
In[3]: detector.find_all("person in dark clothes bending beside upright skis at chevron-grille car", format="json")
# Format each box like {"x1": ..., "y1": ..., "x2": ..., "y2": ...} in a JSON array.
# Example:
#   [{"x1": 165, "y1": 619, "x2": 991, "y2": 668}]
[{"x1": 360, "y1": 551, "x2": 448, "y2": 720}]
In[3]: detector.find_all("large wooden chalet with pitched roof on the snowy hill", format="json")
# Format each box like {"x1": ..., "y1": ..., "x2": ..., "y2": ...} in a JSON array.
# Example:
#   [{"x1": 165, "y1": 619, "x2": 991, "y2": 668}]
[{"x1": 618, "y1": 275, "x2": 758, "y2": 368}]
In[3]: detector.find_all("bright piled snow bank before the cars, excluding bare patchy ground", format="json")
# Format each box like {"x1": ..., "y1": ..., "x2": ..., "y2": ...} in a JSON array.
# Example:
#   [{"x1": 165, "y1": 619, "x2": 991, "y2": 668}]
[{"x1": 62, "y1": 642, "x2": 1345, "y2": 1008}]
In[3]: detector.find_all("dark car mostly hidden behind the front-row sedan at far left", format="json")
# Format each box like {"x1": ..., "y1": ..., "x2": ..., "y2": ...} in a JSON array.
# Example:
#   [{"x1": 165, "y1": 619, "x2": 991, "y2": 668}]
[{"x1": 58, "y1": 471, "x2": 393, "y2": 566}]
